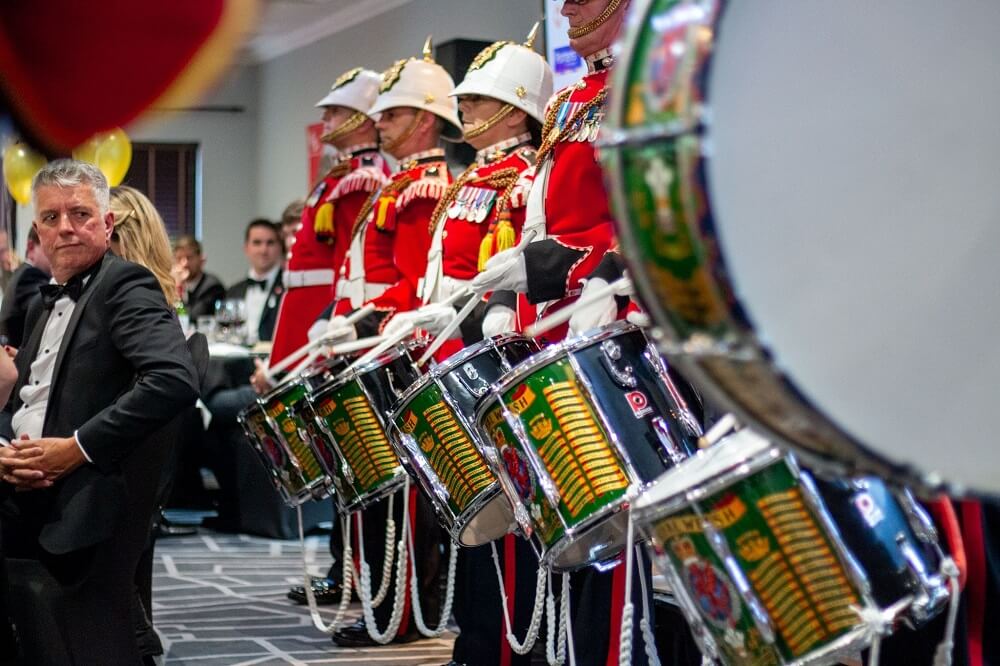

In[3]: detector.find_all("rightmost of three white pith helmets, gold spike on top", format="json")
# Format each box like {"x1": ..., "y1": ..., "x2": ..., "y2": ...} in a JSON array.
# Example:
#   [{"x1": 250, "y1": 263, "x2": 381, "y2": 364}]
[{"x1": 451, "y1": 23, "x2": 553, "y2": 123}]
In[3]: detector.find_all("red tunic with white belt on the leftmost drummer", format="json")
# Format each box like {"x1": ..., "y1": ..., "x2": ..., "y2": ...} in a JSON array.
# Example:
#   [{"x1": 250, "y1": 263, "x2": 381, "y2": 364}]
[{"x1": 270, "y1": 144, "x2": 389, "y2": 365}]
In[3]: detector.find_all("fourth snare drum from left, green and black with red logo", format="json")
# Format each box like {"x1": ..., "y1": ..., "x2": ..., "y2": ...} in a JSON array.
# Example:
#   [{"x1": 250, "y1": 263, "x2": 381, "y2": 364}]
[{"x1": 476, "y1": 322, "x2": 701, "y2": 570}]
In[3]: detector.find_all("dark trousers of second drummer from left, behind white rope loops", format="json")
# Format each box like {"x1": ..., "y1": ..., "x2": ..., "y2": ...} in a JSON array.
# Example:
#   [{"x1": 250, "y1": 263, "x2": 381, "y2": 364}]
[{"x1": 352, "y1": 487, "x2": 447, "y2": 636}]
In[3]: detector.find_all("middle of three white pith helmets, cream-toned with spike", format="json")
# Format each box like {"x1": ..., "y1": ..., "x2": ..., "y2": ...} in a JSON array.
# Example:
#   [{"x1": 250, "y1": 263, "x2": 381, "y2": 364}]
[{"x1": 369, "y1": 37, "x2": 462, "y2": 138}]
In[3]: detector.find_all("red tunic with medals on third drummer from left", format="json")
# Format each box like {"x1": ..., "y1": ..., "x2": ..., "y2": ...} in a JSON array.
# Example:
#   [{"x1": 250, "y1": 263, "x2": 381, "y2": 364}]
[{"x1": 419, "y1": 134, "x2": 535, "y2": 361}]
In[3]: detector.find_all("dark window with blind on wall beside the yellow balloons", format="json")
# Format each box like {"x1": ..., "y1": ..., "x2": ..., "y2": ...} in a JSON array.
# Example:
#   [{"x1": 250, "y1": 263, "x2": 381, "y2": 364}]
[{"x1": 122, "y1": 143, "x2": 198, "y2": 240}]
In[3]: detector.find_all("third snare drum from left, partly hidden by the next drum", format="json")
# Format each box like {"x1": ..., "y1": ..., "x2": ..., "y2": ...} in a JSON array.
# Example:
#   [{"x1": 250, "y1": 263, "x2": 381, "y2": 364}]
[{"x1": 391, "y1": 335, "x2": 538, "y2": 546}]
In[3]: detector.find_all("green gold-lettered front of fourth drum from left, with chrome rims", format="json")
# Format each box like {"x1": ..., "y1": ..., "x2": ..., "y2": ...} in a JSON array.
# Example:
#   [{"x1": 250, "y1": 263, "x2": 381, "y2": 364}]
[{"x1": 476, "y1": 332, "x2": 631, "y2": 571}]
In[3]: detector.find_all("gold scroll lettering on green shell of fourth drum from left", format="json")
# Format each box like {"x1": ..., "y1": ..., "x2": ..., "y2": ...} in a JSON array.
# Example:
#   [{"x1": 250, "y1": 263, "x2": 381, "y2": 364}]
[{"x1": 538, "y1": 382, "x2": 628, "y2": 518}]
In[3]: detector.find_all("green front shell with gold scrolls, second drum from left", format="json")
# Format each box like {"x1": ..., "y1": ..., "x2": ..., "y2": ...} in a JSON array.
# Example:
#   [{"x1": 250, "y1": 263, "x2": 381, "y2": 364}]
[{"x1": 309, "y1": 372, "x2": 405, "y2": 512}]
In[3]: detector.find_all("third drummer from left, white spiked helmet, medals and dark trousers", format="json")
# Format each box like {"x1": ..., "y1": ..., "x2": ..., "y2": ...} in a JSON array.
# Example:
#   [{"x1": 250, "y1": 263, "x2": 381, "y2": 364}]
[{"x1": 386, "y1": 26, "x2": 552, "y2": 666}]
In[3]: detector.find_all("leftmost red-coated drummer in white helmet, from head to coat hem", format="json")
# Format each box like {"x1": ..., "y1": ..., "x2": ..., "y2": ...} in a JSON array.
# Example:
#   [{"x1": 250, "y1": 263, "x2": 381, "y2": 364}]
[{"x1": 270, "y1": 67, "x2": 389, "y2": 365}]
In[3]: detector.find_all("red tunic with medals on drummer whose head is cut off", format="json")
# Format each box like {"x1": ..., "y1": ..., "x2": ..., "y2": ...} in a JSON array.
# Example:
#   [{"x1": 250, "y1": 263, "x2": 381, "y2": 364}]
[{"x1": 518, "y1": 70, "x2": 614, "y2": 341}]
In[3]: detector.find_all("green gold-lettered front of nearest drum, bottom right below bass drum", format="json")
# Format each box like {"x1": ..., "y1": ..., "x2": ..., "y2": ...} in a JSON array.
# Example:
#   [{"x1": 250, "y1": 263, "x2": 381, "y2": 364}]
[{"x1": 633, "y1": 440, "x2": 874, "y2": 666}]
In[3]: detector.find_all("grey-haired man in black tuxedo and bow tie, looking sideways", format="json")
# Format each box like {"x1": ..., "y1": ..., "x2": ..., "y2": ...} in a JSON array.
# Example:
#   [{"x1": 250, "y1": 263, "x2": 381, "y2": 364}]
[{"x1": 0, "y1": 160, "x2": 197, "y2": 664}]
